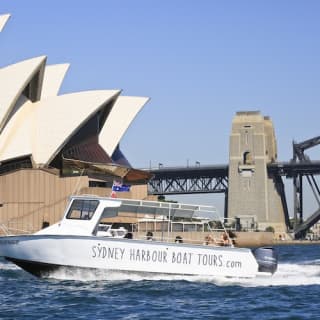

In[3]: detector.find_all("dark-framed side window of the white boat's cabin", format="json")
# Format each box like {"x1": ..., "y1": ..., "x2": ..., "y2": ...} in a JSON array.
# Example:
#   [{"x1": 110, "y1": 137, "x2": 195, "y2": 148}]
[{"x1": 67, "y1": 199, "x2": 99, "y2": 220}]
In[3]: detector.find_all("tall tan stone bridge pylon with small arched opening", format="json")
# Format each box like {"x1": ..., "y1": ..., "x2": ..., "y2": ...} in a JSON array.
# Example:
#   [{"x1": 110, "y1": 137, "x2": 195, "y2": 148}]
[{"x1": 228, "y1": 111, "x2": 289, "y2": 233}]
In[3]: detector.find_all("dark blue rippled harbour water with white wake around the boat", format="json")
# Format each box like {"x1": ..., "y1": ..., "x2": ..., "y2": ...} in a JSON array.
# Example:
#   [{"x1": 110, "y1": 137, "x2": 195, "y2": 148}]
[{"x1": 0, "y1": 245, "x2": 320, "y2": 320}]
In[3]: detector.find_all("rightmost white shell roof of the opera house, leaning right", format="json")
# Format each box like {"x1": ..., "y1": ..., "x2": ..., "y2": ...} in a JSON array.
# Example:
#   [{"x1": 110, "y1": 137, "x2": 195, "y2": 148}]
[{"x1": 99, "y1": 96, "x2": 149, "y2": 156}]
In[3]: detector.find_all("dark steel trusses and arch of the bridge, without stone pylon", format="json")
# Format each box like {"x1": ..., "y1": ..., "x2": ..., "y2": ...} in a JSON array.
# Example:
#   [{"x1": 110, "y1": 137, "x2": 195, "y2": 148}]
[{"x1": 148, "y1": 136, "x2": 320, "y2": 238}]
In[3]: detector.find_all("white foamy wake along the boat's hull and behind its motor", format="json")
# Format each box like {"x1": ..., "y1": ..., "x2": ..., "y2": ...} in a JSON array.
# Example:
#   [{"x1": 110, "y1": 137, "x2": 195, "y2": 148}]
[{"x1": 44, "y1": 261, "x2": 320, "y2": 287}]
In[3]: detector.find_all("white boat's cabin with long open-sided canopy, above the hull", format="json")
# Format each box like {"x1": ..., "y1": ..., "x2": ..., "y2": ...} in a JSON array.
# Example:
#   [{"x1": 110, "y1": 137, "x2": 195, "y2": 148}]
[{"x1": 38, "y1": 195, "x2": 226, "y2": 245}]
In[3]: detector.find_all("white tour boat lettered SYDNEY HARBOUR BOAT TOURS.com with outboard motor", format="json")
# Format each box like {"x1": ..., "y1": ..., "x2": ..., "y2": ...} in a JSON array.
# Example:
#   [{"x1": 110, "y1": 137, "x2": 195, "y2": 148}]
[{"x1": 0, "y1": 196, "x2": 277, "y2": 278}]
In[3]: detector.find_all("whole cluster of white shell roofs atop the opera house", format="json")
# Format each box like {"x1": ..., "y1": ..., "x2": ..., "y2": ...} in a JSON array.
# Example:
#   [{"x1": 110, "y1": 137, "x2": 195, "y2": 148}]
[{"x1": 0, "y1": 14, "x2": 149, "y2": 178}]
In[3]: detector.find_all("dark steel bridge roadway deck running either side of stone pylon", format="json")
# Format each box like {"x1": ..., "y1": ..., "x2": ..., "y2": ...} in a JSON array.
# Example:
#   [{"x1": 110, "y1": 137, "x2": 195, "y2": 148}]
[{"x1": 148, "y1": 161, "x2": 320, "y2": 195}]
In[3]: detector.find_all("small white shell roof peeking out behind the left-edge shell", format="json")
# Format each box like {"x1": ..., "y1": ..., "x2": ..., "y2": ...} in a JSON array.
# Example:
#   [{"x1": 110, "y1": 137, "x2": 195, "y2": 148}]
[{"x1": 41, "y1": 63, "x2": 70, "y2": 99}]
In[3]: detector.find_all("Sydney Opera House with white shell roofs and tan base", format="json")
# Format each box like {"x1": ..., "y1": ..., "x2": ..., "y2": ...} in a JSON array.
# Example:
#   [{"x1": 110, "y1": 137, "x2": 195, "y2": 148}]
[{"x1": 0, "y1": 15, "x2": 149, "y2": 233}]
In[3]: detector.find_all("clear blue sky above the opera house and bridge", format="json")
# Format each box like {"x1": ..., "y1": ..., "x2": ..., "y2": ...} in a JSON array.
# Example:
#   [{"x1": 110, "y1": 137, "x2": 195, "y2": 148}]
[{"x1": 0, "y1": 0, "x2": 320, "y2": 215}]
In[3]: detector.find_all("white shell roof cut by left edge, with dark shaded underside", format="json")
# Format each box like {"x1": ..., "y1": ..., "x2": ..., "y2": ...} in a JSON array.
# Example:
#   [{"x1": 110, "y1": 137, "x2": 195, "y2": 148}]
[{"x1": 0, "y1": 56, "x2": 46, "y2": 133}]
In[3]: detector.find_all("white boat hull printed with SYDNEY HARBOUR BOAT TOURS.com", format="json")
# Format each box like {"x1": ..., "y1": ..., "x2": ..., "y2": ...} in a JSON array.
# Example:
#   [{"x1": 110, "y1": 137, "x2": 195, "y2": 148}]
[{"x1": 0, "y1": 235, "x2": 258, "y2": 278}]
